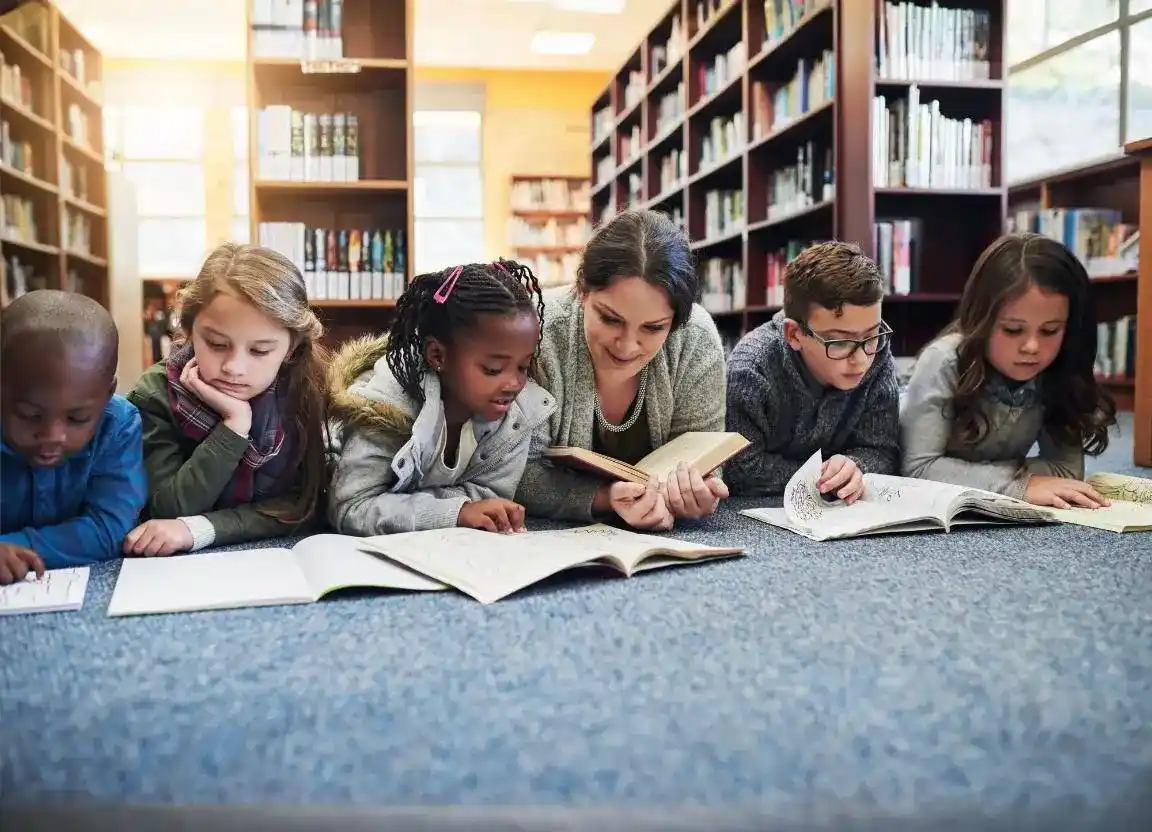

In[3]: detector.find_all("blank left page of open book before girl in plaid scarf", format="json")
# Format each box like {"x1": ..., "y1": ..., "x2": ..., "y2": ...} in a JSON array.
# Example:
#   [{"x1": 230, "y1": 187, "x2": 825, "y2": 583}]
[{"x1": 108, "y1": 549, "x2": 316, "y2": 615}]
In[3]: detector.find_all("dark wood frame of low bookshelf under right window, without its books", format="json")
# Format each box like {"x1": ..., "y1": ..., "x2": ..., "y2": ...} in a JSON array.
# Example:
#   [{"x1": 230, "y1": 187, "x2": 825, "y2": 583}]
[{"x1": 1008, "y1": 153, "x2": 1140, "y2": 410}]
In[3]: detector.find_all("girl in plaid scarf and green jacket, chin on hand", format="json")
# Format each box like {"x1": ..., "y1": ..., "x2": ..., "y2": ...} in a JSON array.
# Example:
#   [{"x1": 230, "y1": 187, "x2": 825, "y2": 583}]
[{"x1": 124, "y1": 243, "x2": 327, "y2": 555}]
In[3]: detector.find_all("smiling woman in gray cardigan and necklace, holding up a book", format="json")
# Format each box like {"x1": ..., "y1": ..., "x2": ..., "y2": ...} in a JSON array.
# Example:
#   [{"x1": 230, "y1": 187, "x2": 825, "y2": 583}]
[{"x1": 516, "y1": 211, "x2": 728, "y2": 529}]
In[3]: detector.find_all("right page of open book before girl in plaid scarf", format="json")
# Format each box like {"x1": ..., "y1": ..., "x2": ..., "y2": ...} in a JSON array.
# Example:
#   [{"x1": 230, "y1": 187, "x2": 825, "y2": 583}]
[{"x1": 293, "y1": 532, "x2": 448, "y2": 599}]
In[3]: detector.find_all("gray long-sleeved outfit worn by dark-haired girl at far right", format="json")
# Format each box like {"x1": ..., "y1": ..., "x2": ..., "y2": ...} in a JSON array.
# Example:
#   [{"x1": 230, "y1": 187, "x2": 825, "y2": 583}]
[{"x1": 900, "y1": 334, "x2": 1084, "y2": 498}]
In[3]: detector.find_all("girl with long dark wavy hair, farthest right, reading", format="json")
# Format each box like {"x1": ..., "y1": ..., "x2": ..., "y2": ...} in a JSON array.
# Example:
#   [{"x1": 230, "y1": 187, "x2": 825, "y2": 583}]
[{"x1": 900, "y1": 234, "x2": 1116, "y2": 508}]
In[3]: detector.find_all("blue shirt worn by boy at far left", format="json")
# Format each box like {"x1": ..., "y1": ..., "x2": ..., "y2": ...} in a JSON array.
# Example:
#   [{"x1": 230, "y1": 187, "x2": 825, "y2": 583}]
[{"x1": 0, "y1": 395, "x2": 147, "y2": 569}]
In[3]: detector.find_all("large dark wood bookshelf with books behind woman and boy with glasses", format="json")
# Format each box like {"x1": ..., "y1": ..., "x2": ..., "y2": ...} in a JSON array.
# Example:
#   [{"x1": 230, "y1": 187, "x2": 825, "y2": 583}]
[{"x1": 591, "y1": 0, "x2": 1006, "y2": 355}]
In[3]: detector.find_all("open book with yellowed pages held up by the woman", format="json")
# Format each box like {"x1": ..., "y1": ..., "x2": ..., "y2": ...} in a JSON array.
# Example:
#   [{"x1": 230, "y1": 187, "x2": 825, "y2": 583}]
[{"x1": 543, "y1": 431, "x2": 749, "y2": 485}]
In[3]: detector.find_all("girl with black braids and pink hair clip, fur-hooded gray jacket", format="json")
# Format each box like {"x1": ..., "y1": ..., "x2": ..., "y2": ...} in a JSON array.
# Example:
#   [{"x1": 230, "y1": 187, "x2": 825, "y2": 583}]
[{"x1": 328, "y1": 260, "x2": 555, "y2": 536}]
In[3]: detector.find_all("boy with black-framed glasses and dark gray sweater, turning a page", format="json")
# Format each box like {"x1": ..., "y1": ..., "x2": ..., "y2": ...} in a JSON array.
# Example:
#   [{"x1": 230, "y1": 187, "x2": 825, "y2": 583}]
[{"x1": 725, "y1": 242, "x2": 900, "y2": 504}]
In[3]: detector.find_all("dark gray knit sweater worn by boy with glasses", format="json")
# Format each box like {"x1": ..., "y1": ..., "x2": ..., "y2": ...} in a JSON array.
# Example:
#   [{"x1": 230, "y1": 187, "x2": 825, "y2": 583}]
[{"x1": 725, "y1": 312, "x2": 900, "y2": 497}]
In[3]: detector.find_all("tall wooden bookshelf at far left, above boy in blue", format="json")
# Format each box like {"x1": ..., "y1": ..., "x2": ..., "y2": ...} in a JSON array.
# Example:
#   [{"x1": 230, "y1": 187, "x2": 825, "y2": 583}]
[{"x1": 0, "y1": 2, "x2": 111, "y2": 307}]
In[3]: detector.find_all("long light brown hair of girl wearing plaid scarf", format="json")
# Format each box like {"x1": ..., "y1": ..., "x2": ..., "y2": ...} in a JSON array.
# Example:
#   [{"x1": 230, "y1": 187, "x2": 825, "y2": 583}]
[{"x1": 177, "y1": 243, "x2": 328, "y2": 523}]
